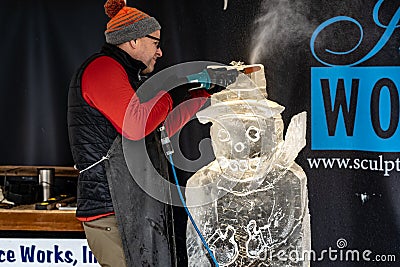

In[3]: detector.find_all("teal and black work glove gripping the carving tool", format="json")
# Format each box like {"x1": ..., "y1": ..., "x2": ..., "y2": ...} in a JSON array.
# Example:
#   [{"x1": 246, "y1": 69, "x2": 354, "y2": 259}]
[{"x1": 186, "y1": 67, "x2": 239, "y2": 94}]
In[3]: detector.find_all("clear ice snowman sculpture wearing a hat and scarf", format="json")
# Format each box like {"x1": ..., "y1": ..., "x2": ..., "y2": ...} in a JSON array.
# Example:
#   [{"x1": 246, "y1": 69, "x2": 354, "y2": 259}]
[{"x1": 186, "y1": 64, "x2": 311, "y2": 267}]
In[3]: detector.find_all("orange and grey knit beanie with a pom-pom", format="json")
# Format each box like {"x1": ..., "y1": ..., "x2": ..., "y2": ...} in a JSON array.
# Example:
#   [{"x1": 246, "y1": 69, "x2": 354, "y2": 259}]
[{"x1": 104, "y1": 0, "x2": 161, "y2": 45}]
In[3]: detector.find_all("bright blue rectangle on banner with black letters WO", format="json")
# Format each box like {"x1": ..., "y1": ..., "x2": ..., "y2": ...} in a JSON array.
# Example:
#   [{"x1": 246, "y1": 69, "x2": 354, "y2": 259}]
[{"x1": 311, "y1": 66, "x2": 400, "y2": 152}]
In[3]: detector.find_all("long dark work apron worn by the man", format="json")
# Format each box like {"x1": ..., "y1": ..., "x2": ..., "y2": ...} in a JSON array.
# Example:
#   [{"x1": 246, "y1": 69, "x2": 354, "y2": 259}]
[{"x1": 105, "y1": 134, "x2": 177, "y2": 267}]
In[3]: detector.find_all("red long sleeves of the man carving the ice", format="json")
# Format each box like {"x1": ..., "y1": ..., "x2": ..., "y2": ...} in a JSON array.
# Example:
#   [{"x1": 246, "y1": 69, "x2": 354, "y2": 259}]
[{"x1": 82, "y1": 56, "x2": 209, "y2": 140}]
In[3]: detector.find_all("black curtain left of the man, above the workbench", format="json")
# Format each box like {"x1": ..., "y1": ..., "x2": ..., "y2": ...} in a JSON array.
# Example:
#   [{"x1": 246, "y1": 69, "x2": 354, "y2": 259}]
[{"x1": 0, "y1": 0, "x2": 106, "y2": 166}]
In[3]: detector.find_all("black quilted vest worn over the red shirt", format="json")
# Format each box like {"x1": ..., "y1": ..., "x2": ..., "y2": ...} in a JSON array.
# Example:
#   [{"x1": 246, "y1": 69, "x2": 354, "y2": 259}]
[{"x1": 67, "y1": 44, "x2": 146, "y2": 217}]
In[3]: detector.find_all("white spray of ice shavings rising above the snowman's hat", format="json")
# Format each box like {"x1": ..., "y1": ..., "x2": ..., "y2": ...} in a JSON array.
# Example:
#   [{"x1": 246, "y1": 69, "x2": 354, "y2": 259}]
[{"x1": 250, "y1": 0, "x2": 315, "y2": 64}]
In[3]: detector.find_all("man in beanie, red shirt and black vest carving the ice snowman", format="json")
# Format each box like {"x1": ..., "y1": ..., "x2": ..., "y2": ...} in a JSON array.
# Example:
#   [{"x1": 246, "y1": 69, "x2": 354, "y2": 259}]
[{"x1": 68, "y1": 0, "x2": 236, "y2": 267}]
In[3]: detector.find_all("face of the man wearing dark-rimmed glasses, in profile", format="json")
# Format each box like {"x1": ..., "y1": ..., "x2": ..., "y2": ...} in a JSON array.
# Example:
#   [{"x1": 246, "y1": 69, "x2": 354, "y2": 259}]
[{"x1": 136, "y1": 30, "x2": 162, "y2": 74}]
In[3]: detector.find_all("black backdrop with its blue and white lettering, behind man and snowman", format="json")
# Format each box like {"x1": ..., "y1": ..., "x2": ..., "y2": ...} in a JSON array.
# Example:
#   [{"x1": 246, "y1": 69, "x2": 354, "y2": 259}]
[{"x1": 0, "y1": 0, "x2": 400, "y2": 267}]
